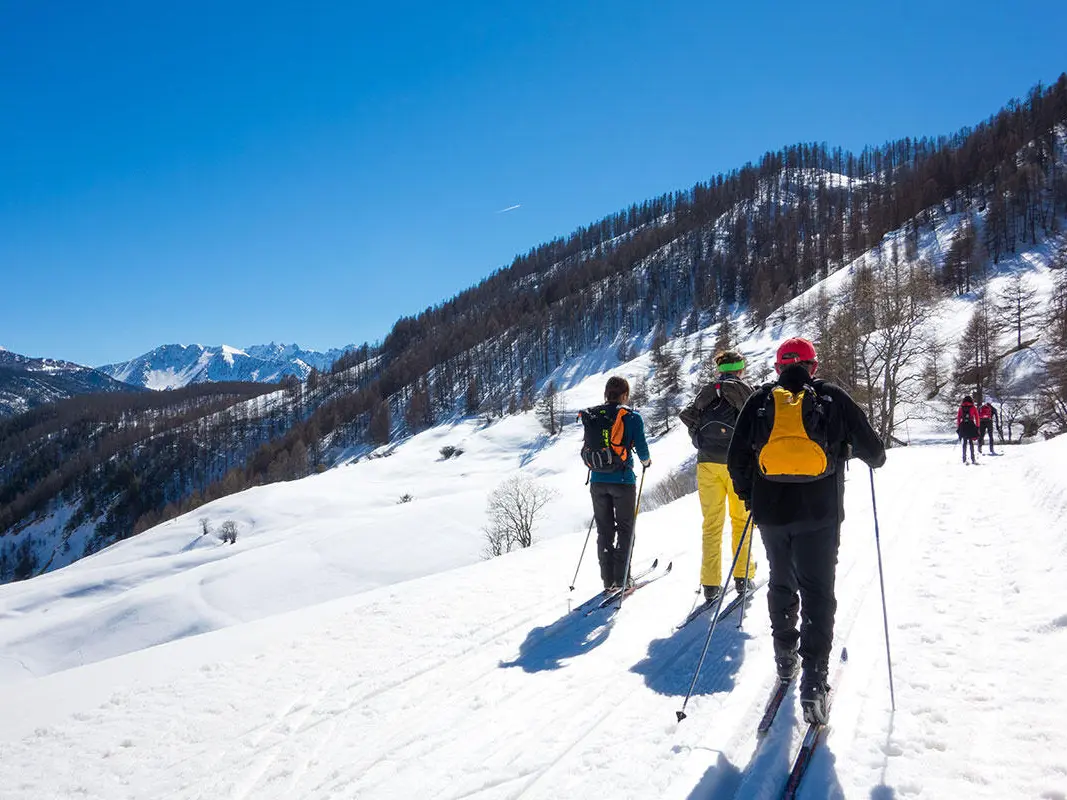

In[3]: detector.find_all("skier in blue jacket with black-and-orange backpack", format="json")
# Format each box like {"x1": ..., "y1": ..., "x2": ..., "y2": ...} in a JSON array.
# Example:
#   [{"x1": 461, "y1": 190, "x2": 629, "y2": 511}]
[{"x1": 578, "y1": 375, "x2": 652, "y2": 592}]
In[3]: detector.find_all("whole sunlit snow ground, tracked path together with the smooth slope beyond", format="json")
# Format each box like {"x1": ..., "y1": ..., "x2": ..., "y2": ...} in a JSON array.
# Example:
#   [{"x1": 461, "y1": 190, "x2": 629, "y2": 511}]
[{"x1": 0, "y1": 398, "x2": 1067, "y2": 800}]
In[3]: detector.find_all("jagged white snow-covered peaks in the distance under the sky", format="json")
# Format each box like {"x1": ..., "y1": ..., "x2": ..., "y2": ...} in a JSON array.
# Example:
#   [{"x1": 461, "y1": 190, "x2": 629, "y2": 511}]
[{"x1": 99, "y1": 342, "x2": 354, "y2": 389}]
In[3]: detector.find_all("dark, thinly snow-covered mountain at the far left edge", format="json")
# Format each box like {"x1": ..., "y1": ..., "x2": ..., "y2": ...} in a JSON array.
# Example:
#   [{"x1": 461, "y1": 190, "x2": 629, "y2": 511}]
[{"x1": 0, "y1": 348, "x2": 137, "y2": 417}]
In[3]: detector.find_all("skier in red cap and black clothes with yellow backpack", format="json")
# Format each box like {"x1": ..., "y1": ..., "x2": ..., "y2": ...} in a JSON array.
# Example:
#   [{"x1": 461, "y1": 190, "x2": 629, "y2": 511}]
[{"x1": 727, "y1": 338, "x2": 886, "y2": 722}]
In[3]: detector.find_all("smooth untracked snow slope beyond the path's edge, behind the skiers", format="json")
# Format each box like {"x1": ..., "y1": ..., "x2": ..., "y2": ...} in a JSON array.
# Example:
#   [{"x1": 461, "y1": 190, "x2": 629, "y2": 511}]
[{"x1": 0, "y1": 359, "x2": 691, "y2": 681}]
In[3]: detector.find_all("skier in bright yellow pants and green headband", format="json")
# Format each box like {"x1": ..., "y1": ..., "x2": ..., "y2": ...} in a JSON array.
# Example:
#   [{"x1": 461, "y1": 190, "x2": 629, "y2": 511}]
[{"x1": 678, "y1": 350, "x2": 755, "y2": 603}]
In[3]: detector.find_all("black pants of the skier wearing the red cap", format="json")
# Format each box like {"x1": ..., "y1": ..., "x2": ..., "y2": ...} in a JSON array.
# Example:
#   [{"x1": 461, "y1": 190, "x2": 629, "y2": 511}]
[{"x1": 760, "y1": 523, "x2": 841, "y2": 673}]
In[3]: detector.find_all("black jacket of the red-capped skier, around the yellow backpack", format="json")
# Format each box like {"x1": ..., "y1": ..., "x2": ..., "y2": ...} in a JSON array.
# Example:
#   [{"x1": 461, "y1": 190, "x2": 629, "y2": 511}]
[{"x1": 727, "y1": 365, "x2": 886, "y2": 526}]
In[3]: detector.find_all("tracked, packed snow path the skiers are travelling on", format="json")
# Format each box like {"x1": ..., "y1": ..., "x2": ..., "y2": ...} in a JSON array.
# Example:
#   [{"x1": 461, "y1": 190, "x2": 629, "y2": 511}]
[{"x1": 0, "y1": 439, "x2": 1067, "y2": 800}]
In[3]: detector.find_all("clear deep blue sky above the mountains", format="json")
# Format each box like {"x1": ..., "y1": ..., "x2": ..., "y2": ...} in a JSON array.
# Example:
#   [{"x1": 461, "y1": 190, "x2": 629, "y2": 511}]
[{"x1": 0, "y1": 0, "x2": 1067, "y2": 365}]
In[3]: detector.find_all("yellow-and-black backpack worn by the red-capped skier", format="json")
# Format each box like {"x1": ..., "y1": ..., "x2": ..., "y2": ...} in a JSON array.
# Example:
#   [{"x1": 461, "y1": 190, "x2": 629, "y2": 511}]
[{"x1": 757, "y1": 385, "x2": 837, "y2": 483}]
